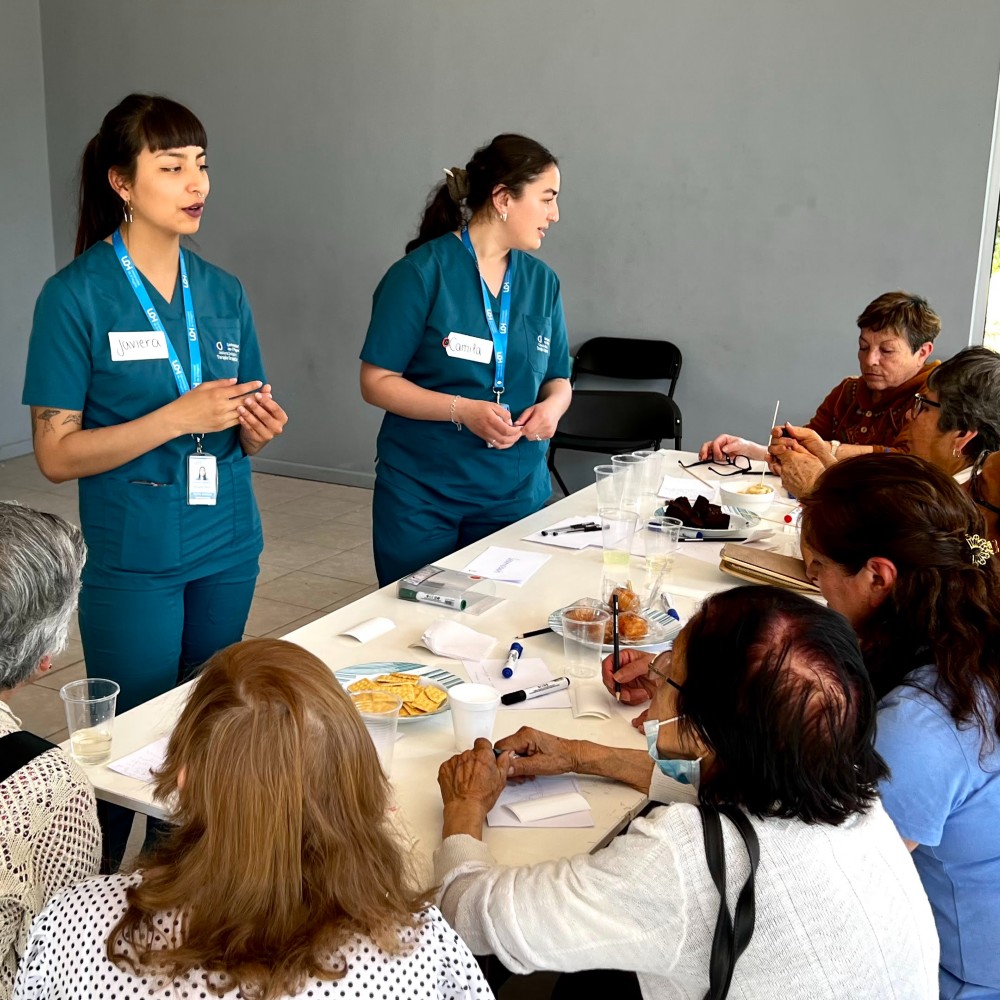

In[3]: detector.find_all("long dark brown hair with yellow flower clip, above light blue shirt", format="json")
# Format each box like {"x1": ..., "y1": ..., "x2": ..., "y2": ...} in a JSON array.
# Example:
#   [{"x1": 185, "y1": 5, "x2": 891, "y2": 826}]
[{"x1": 801, "y1": 454, "x2": 1000, "y2": 754}]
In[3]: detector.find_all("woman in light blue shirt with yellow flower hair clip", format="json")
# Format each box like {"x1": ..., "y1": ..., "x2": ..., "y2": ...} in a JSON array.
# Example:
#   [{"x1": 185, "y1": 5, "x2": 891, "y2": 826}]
[{"x1": 802, "y1": 456, "x2": 1000, "y2": 1000}]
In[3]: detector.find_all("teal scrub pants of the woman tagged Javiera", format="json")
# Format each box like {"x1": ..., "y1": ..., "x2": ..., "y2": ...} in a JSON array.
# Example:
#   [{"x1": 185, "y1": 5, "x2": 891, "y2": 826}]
[{"x1": 80, "y1": 556, "x2": 258, "y2": 715}]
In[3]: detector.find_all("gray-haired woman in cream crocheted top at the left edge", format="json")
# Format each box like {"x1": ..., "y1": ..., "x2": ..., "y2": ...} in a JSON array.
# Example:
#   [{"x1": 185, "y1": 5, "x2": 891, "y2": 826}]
[{"x1": 0, "y1": 503, "x2": 101, "y2": 1000}]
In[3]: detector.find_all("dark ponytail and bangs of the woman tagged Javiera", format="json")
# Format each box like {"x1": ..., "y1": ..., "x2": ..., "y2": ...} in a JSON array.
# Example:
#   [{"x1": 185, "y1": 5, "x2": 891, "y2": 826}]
[{"x1": 74, "y1": 94, "x2": 208, "y2": 257}]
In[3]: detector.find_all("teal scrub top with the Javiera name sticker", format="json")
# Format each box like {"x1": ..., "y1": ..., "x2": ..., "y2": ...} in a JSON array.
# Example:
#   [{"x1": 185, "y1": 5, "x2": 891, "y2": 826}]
[{"x1": 21, "y1": 241, "x2": 266, "y2": 589}]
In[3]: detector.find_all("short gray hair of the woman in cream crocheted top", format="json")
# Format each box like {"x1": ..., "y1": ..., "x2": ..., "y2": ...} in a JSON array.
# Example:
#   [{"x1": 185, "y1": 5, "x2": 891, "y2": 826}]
[{"x1": 0, "y1": 501, "x2": 87, "y2": 691}]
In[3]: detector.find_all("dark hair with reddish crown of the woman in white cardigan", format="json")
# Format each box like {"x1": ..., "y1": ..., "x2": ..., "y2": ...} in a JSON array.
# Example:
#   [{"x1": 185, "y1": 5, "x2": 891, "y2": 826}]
[{"x1": 678, "y1": 587, "x2": 888, "y2": 826}]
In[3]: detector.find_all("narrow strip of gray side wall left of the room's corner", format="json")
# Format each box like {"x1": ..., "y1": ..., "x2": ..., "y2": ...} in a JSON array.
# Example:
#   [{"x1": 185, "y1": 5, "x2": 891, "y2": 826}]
[{"x1": 0, "y1": 0, "x2": 55, "y2": 460}]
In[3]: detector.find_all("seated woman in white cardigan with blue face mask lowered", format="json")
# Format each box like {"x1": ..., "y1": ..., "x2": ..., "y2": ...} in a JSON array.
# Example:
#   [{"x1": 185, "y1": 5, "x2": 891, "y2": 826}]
[{"x1": 435, "y1": 587, "x2": 938, "y2": 1000}]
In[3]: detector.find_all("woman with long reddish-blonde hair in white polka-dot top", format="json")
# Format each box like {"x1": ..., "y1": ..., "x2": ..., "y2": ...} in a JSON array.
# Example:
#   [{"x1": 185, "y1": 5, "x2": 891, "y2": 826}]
[{"x1": 14, "y1": 639, "x2": 490, "y2": 1000}]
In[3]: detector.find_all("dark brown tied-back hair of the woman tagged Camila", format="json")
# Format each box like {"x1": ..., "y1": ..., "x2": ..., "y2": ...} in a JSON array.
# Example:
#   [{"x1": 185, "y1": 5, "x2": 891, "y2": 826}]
[{"x1": 406, "y1": 133, "x2": 559, "y2": 253}]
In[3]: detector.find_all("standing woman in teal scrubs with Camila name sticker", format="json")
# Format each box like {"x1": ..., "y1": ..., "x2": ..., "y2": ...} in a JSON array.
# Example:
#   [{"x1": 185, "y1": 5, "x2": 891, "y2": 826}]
[{"x1": 361, "y1": 135, "x2": 571, "y2": 585}]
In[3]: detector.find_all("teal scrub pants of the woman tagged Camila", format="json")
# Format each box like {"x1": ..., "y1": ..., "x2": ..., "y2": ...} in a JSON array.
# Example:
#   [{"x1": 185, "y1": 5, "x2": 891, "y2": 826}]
[{"x1": 372, "y1": 476, "x2": 548, "y2": 587}]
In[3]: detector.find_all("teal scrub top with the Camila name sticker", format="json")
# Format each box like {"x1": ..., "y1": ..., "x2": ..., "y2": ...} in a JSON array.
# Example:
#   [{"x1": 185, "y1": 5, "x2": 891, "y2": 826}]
[{"x1": 361, "y1": 233, "x2": 569, "y2": 504}]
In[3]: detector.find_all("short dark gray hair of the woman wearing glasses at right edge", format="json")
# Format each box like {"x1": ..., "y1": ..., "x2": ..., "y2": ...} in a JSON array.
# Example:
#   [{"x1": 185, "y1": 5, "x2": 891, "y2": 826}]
[{"x1": 927, "y1": 347, "x2": 1000, "y2": 458}]
